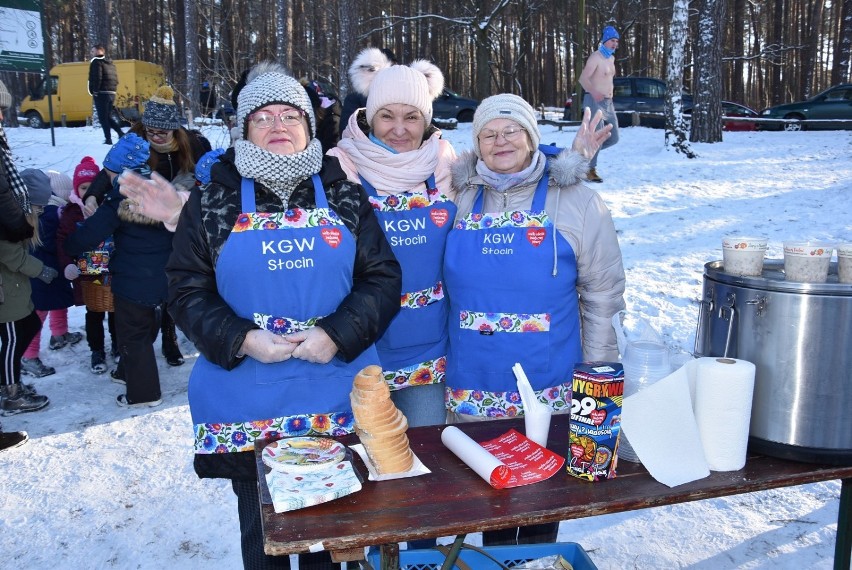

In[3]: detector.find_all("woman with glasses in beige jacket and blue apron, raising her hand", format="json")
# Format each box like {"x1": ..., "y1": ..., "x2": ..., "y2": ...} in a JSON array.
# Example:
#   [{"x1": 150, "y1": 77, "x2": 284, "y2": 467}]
[{"x1": 444, "y1": 94, "x2": 624, "y2": 545}]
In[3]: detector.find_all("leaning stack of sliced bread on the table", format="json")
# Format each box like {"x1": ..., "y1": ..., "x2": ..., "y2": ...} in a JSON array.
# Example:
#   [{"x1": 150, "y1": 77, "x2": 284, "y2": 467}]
[{"x1": 349, "y1": 366, "x2": 414, "y2": 475}]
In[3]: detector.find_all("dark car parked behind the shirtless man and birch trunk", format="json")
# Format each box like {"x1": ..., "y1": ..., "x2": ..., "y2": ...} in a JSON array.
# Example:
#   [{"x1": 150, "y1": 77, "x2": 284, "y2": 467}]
[{"x1": 564, "y1": 77, "x2": 692, "y2": 128}]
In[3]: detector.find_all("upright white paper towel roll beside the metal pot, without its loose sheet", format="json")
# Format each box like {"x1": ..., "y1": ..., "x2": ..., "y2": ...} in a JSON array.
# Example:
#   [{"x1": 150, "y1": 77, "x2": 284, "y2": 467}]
[{"x1": 692, "y1": 358, "x2": 755, "y2": 471}]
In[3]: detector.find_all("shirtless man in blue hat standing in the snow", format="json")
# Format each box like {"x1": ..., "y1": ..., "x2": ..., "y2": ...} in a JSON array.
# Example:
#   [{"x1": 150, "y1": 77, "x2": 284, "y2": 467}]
[{"x1": 580, "y1": 26, "x2": 620, "y2": 182}]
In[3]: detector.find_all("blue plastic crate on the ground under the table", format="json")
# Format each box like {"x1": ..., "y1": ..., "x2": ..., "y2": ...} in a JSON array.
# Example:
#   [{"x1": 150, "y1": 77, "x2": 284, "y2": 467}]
[{"x1": 367, "y1": 542, "x2": 597, "y2": 570}]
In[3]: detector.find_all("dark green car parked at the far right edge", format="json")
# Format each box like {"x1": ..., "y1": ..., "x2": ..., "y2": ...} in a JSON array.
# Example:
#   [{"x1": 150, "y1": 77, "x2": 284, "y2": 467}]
[{"x1": 760, "y1": 83, "x2": 852, "y2": 131}]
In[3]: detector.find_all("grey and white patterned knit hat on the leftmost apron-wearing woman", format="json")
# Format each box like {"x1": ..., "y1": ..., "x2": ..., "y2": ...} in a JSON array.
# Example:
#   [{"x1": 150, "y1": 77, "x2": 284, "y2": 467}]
[{"x1": 237, "y1": 61, "x2": 317, "y2": 139}]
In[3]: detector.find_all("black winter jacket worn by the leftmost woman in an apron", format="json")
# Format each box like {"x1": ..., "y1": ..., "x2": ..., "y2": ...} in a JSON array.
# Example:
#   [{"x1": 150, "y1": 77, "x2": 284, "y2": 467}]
[{"x1": 166, "y1": 149, "x2": 402, "y2": 370}]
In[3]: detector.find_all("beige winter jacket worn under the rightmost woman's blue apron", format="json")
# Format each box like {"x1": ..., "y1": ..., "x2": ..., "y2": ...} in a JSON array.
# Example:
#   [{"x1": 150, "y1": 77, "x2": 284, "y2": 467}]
[{"x1": 453, "y1": 150, "x2": 625, "y2": 362}]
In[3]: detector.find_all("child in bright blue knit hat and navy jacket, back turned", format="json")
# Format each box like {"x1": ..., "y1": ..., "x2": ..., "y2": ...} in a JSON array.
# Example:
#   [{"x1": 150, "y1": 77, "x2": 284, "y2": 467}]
[{"x1": 65, "y1": 133, "x2": 172, "y2": 407}]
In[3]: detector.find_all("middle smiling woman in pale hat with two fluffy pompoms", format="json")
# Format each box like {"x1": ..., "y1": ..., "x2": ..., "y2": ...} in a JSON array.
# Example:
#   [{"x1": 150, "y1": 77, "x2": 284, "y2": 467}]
[{"x1": 328, "y1": 48, "x2": 456, "y2": 427}]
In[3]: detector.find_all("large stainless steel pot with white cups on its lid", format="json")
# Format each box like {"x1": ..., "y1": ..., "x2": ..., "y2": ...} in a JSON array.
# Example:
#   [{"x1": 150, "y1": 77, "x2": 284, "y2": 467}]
[{"x1": 695, "y1": 261, "x2": 852, "y2": 465}]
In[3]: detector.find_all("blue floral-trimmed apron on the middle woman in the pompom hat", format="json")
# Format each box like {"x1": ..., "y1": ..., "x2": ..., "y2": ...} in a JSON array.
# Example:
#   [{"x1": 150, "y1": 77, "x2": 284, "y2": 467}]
[{"x1": 361, "y1": 175, "x2": 456, "y2": 390}]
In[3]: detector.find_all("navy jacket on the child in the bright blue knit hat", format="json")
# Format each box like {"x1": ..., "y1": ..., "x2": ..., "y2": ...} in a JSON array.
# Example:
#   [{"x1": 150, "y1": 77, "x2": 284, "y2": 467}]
[{"x1": 65, "y1": 182, "x2": 173, "y2": 307}]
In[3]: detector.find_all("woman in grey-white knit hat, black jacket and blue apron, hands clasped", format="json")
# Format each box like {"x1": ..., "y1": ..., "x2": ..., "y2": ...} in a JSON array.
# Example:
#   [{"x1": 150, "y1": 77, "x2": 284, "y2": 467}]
[{"x1": 165, "y1": 63, "x2": 401, "y2": 569}]
